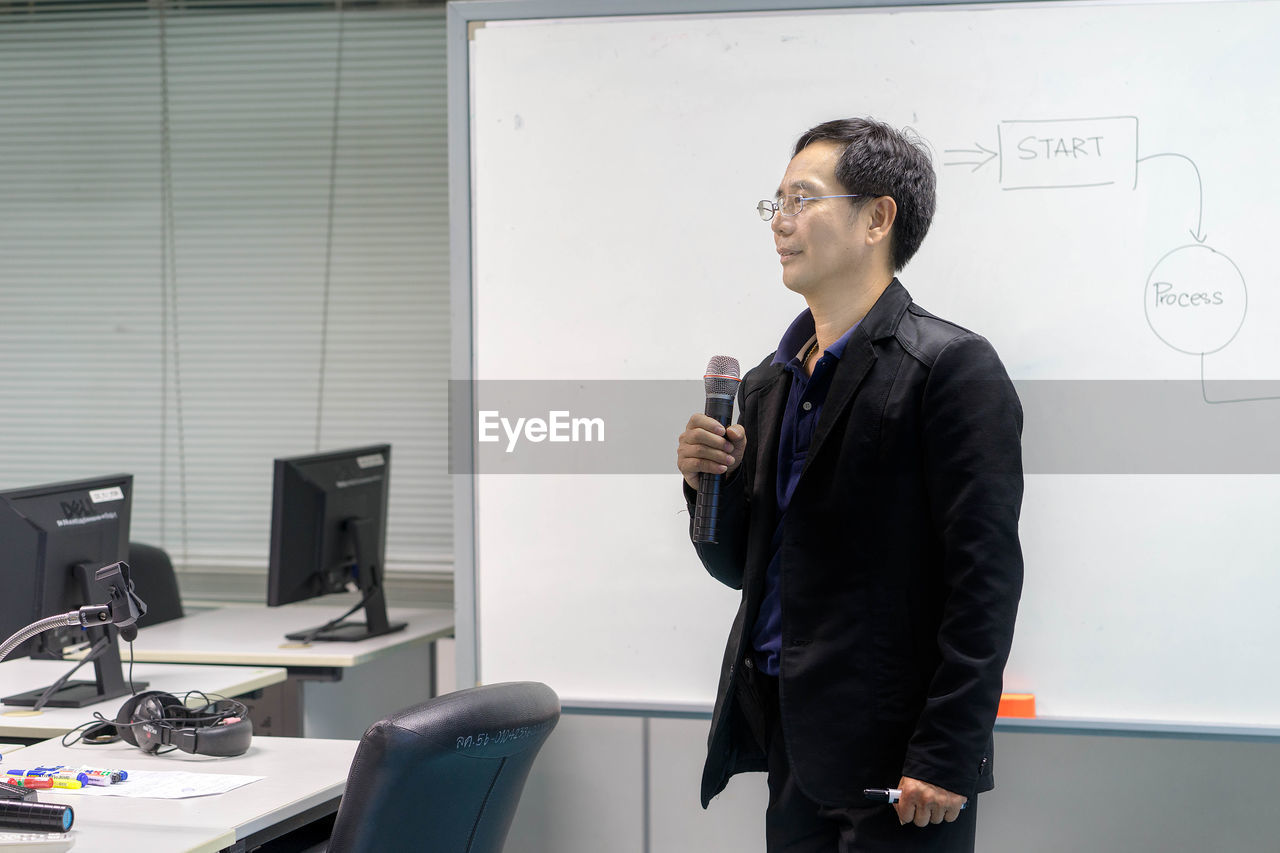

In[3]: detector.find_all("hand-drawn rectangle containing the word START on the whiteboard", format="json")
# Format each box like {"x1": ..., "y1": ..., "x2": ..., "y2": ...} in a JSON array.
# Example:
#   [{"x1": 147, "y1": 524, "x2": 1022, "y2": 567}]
[{"x1": 1000, "y1": 115, "x2": 1138, "y2": 190}]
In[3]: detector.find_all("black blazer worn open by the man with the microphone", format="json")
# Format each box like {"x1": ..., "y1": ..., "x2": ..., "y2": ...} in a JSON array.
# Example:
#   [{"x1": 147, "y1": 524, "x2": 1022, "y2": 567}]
[{"x1": 686, "y1": 279, "x2": 1023, "y2": 806}]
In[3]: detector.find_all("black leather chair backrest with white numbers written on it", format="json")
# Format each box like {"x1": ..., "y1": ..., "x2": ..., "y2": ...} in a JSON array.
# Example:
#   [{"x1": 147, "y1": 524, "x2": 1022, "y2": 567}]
[{"x1": 329, "y1": 681, "x2": 559, "y2": 853}]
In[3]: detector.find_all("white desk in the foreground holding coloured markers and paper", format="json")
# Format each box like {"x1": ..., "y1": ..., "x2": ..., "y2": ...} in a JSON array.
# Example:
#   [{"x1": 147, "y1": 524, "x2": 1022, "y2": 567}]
[{"x1": 11, "y1": 738, "x2": 358, "y2": 853}]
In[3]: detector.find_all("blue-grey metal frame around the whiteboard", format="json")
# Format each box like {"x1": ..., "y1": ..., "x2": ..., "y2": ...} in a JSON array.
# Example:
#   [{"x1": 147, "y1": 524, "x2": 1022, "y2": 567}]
[{"x1": 445, "y1": 0, "x2": 1280, "y2": 742}]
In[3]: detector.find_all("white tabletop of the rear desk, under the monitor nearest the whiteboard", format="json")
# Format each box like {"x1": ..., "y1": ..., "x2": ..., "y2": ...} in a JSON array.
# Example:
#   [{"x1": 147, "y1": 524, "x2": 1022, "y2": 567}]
[{"x1": 112, "y1": 605, "x2": 453, "y2": 667}]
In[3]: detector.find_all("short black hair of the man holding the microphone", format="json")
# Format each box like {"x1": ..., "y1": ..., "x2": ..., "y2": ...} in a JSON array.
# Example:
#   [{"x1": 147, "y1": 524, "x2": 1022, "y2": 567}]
[{"x1": 794, "y1": 118, "x2": 937, "y2": 272}]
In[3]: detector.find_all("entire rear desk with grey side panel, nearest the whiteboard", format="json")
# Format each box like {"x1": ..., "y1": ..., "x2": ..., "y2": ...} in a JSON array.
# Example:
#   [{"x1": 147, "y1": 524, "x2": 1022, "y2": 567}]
[{"x1": 103, "y1": 605, "x2": 453, "y2": 739}]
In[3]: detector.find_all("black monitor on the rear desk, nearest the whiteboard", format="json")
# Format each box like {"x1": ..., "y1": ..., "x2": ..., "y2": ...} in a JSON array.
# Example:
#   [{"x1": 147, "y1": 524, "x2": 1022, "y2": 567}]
[{"x1": 266, "y1": 444, "x2": 404, "y2": 642}]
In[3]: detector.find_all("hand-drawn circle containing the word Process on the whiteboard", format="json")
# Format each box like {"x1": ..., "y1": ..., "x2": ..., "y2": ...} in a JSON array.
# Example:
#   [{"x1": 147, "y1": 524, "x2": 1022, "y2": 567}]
[{"x1": 1142, "y1": 243, "x2": 1249, "y2": 355}]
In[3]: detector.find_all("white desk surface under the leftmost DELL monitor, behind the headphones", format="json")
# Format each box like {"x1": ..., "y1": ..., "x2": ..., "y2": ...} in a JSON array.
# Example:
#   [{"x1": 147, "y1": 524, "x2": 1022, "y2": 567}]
[{"x1": 0, "y1": 649, "x2": 288, "y2": 738}]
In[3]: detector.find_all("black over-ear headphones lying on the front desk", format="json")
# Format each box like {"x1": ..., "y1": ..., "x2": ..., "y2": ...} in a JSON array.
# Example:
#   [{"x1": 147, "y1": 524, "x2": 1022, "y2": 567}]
[{"x1": 115, "y1": 690, "x2": 253, "y2": 756}]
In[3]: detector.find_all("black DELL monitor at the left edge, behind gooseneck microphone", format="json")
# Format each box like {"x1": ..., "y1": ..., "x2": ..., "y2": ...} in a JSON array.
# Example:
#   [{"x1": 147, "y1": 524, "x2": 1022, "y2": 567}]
[{"x1": 0, "y1": 474, "x2": 146, "y2": 708}]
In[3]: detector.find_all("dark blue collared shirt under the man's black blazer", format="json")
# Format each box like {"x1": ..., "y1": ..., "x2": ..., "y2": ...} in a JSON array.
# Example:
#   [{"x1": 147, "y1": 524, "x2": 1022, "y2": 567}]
[{"x1": 751, "y1": 310, "x2": 858, "y2": 676}]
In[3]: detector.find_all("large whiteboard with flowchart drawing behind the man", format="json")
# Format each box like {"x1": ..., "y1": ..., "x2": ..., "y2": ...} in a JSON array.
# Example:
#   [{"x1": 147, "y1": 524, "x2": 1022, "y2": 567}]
[{"x1": 453, "y1": 1, "x2": 1280, "y2": 726}]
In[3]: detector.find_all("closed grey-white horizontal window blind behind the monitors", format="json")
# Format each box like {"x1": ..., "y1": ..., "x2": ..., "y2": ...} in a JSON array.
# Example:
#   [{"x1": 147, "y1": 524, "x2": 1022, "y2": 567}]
[{"x1": 0, "y1": 3, "x2": 452, "y2": 581}]
